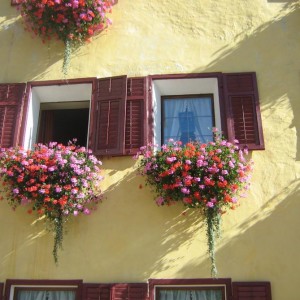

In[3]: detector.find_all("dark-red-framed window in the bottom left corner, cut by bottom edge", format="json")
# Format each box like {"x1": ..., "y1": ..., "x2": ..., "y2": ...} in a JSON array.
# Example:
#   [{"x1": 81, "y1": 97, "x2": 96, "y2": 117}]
[{"x1": 5, "y1": 279, "x2": 82, "y2": 300}]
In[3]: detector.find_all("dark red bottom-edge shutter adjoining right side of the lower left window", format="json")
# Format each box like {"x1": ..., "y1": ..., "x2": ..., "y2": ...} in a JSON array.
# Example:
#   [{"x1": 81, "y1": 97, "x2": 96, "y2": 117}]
[{"x1": 82, "y1": 283, "x2": 111, "y2": 300}]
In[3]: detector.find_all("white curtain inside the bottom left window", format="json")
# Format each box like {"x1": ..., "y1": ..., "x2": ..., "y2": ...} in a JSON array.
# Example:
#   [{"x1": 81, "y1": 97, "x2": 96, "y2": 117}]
[{"x1": 17, "y1": 290, "x2": 75, "y2": 300}]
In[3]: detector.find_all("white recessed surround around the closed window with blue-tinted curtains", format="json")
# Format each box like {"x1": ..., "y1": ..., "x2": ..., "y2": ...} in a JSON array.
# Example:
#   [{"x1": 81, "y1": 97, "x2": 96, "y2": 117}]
[{"x1": 151, "y1": 77, "x2": 221, "y2": 147}]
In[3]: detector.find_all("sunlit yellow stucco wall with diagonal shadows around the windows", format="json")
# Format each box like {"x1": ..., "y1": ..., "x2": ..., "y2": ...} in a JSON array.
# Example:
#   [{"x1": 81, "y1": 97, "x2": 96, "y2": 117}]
[{"x1": 0, "y1": 0, "x2": 300, "y2": 300}]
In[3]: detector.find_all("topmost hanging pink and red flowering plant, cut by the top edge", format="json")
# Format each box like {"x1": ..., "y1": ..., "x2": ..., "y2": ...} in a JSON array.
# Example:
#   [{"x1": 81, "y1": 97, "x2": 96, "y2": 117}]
[{"x1": 17, "y1": 0, "x2": 113, "y2": 75}]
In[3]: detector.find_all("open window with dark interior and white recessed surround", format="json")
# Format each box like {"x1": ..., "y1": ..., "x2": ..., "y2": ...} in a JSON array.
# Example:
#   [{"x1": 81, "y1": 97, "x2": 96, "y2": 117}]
[{"x1": 24, "y1": 81, "x2": 92, "y2": 149}]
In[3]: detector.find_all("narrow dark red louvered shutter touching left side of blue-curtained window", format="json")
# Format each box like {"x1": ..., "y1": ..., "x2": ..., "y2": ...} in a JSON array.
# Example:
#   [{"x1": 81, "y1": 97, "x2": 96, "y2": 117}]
[{"x1": 125, "y1": 77, "x2": 147, "y2": 154}]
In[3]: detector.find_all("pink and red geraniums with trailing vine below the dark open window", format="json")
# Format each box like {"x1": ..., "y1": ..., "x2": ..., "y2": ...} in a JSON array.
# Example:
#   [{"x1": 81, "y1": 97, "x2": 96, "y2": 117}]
[{"x1": 0, "y1": 142, "x2": 102, "y2": 262}]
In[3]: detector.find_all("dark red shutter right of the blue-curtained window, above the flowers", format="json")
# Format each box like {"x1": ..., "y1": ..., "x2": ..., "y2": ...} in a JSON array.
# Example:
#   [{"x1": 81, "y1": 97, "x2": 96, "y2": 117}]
[{"x1": 223, "y1": 73, "x2": 264, "y2": 150}]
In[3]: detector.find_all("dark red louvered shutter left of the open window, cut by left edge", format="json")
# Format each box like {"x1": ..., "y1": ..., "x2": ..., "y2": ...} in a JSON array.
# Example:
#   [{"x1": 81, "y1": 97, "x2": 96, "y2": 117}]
[{"x1": 0, "y1": 83, "x2": 26, "y2": 148}]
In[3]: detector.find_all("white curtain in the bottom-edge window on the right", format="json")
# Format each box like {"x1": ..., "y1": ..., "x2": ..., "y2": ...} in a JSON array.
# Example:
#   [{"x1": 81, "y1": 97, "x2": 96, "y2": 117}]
[{"x1": 158, "y1": 290, "x2": 222, "y2": 300}]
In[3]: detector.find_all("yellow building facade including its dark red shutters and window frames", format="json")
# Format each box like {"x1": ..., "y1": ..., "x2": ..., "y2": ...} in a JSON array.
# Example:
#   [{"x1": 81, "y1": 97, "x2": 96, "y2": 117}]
[{"x1": 0, "y1": 0, "x2": 300, "y2": 300}]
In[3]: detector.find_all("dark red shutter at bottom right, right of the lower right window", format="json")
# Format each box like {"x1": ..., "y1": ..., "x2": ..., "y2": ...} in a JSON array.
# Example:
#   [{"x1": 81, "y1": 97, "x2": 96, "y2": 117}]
[{"x1": 232, "y1": 282, "x2": 272, "y2": 300}]
